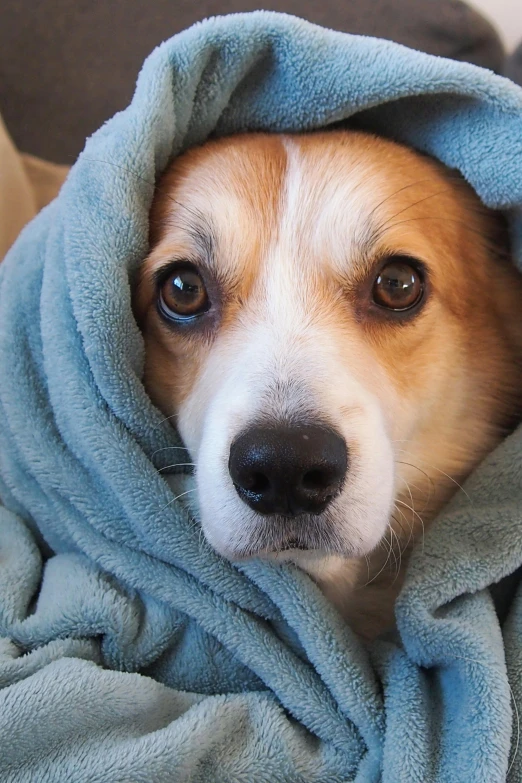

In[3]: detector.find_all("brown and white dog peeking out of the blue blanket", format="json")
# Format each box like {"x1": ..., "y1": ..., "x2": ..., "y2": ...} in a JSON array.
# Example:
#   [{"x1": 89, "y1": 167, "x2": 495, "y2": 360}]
[{"x1": 131, "y1": 131, "x2": 522, "y2": 637}]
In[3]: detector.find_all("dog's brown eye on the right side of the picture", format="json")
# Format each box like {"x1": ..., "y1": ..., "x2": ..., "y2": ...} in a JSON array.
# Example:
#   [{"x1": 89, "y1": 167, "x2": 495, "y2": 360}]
[{"x1": 372, "y1": 257, "x2": 424, "y2": 310}]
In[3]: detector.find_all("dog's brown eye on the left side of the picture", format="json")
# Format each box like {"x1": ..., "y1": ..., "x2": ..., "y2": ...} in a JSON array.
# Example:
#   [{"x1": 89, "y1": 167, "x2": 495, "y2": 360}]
[{"x1": 158, "y1": 263, "x2": 210, "y2": 320}]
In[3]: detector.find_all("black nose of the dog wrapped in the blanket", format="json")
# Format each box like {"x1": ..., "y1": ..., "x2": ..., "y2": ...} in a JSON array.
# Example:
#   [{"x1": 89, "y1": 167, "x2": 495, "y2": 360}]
[{"x1": 228, "y1": 425, "x2": 348, "y2": 516}]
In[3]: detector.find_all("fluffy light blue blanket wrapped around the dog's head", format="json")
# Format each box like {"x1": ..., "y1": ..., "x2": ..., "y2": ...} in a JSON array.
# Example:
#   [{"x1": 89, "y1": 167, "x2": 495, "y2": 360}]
[{"x1": 0, "y1": 12, "x2": 522, "y2": 783}]
